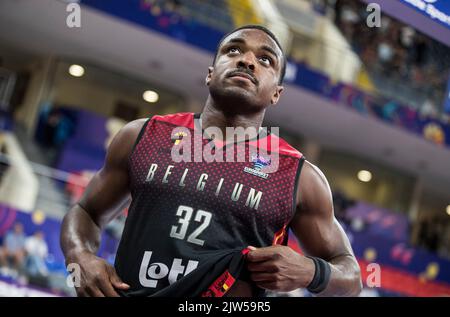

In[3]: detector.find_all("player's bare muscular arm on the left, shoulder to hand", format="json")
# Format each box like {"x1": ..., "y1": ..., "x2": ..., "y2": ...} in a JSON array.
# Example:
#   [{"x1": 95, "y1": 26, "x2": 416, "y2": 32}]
[{"x1": 61, "y1": 119, "x2": 145, "y2": 296}]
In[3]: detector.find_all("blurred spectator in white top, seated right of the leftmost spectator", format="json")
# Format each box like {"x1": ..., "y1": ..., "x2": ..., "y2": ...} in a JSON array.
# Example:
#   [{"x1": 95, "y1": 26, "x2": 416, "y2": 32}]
[{"x1": 25, "y1": 231, "x2": 48, "y2": 277}]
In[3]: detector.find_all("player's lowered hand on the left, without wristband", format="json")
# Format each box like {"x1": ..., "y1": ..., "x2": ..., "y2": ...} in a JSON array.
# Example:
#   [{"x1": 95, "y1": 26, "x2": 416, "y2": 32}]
[{"x1": 67, "y1": 252, "x2": 130, "y2": 297}]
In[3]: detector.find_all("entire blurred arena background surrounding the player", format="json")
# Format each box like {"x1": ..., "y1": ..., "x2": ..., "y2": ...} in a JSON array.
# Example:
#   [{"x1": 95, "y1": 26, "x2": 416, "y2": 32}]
[{"x1": 0, "y1": 0, "x2": 450, "y2": 296}]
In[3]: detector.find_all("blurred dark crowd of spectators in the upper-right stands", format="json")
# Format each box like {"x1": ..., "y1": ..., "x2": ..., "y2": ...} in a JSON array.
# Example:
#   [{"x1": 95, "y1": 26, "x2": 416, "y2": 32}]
[{"x1": 318, "y1": 0, "x2": 450, "y2": 112}]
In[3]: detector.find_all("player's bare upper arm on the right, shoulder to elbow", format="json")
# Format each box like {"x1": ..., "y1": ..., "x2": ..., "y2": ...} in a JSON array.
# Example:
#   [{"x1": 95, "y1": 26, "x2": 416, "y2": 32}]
[{"x1": 290, "y1": 162, "x2": 352, "y2": 260}]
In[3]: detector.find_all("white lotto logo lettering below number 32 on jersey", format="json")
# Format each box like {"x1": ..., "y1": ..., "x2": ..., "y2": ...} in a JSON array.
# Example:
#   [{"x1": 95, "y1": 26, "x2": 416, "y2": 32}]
[{"x1": 139, "y1": 251, "x2": 198, "y2": 288}]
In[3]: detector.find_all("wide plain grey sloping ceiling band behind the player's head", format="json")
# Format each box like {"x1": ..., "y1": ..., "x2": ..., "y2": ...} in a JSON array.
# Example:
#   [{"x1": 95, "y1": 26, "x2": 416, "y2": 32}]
[{"x1": 0, "y1": 0, "x2": 450, "y2": 196}]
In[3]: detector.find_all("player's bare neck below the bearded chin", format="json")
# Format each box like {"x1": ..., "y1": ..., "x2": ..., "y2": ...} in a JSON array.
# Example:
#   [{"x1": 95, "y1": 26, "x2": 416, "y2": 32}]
[{"x1": 201, "y1": 96, "x2": 265, "y2": 135}]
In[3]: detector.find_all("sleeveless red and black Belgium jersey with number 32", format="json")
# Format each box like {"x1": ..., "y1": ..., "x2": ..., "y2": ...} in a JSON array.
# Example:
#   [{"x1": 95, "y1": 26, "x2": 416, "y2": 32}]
[{"x1": 115, "y1": 113, "x2": 304, "y2": 297}]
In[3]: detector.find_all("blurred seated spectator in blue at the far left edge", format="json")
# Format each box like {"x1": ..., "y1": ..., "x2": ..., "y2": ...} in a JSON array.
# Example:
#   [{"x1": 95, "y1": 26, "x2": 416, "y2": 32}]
[{"x1": 0, "y1": 223, "x2": 25, "y2": 275}]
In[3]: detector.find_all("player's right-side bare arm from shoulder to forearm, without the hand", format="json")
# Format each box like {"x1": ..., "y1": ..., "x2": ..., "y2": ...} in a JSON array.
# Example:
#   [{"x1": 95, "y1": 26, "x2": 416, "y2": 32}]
[{"x1": 291, "y1": 161, "x2": 362, "y2": 296}]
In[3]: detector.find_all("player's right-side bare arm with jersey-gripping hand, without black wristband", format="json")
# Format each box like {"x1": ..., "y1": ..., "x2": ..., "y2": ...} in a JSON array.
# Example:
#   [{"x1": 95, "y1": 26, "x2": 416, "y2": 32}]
[{"x1": 247, "y1": 162, "x2": 362, "y2": 296}]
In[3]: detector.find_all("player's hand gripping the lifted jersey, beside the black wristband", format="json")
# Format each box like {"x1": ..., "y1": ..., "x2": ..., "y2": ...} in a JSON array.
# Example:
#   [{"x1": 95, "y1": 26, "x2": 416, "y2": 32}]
[{"x1": 247, "y1": 245, "x2": 315, "y2": 292}]
